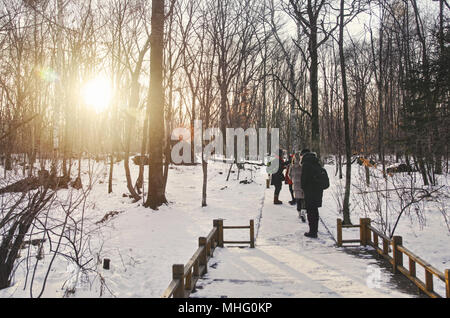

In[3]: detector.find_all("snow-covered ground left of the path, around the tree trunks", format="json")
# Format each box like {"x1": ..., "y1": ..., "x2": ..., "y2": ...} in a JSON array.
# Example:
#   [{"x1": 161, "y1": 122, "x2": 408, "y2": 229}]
[{"x1": 0, "y1": 163, "x2": 265, "y2": 297}]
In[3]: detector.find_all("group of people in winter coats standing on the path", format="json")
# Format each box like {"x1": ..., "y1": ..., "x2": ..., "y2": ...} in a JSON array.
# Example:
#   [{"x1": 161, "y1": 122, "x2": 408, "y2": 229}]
[{"x1": 271, "y1": 149, "x2": 323, "y2": 238}]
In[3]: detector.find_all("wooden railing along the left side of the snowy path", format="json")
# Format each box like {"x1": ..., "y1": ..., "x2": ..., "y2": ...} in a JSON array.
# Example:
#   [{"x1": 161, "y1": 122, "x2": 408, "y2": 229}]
[{"x1": 162, "y1": 220, "x2": 255, "y2": 298}]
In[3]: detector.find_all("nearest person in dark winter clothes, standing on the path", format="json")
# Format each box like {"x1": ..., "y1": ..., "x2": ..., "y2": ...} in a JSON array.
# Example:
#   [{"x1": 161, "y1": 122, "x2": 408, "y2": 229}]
[{"x1": 301, "y1": 149, "x2": 323, "y2": 238}]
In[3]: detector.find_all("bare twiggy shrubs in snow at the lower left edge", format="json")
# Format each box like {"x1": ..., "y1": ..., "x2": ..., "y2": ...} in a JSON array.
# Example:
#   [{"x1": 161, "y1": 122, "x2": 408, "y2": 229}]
[{"x1": 0, "y1": 163, "x2": 107, "y2": 297}]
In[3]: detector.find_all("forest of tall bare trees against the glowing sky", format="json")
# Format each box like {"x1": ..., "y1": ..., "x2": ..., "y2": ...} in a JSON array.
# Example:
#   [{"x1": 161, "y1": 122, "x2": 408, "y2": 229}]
[{"x1": 0, "y1": 0, "x2": 450, "y2": 208}]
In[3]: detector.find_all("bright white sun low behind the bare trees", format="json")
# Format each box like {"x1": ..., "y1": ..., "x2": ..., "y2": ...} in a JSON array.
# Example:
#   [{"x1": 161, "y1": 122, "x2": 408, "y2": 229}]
[{"x1": 81, "y1": 77, "x2": 112, "y2": 113}]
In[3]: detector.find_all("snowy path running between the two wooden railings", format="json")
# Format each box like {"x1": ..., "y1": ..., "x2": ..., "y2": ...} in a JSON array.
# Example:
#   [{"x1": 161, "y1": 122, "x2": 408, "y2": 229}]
[{"x1": 191, "y1": 184, "x2": 411, "y2": 298}]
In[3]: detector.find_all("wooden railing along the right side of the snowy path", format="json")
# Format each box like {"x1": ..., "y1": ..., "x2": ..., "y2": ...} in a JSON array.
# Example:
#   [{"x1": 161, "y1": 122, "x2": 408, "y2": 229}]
[{"x1": 337, "y1": 218, "x2": 450, "y2": 298}]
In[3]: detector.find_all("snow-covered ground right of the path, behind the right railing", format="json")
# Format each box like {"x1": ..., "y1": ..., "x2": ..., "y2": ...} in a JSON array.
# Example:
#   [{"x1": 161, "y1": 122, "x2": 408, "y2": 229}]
[{"x1": 320, "y1": 164, "x2": 450, "y2": 296}]
